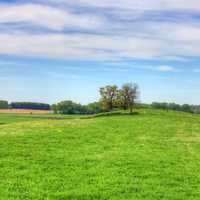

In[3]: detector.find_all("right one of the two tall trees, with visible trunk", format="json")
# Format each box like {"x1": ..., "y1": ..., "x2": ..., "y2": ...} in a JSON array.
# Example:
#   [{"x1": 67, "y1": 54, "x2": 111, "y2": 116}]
[{"x1": 119, "y1": 83, "x2": 138, "y2": 113}]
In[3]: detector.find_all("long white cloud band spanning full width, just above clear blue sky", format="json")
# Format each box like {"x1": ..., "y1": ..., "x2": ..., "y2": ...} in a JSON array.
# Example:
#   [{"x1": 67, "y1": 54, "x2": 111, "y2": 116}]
[{"x1": 0, "y1": 33, "x2": 200, "y2": 60}]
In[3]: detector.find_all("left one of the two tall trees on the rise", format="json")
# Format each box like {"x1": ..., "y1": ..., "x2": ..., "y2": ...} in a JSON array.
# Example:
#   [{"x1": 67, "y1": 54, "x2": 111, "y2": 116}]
[{"x1": 100, "y1": 85, "x2": 118, "y2": 111}]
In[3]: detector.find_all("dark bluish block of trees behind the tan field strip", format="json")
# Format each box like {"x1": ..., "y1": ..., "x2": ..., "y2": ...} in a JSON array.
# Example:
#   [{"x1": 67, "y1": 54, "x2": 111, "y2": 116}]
[{"x1": 10, "y1": 102, "x2": 51, "y2": 110}]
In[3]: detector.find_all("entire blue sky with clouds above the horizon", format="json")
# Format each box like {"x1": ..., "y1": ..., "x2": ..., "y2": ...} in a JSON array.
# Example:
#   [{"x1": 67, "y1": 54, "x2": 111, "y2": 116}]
[{"x1": 0, "y1": 0, "x2": 200, "y2": 104}]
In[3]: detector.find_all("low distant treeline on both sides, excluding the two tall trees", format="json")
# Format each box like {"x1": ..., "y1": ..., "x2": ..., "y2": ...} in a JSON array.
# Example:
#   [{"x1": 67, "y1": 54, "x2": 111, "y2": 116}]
[{"x1": 0, "y1": 100, "x2": 200, "y2": 114}]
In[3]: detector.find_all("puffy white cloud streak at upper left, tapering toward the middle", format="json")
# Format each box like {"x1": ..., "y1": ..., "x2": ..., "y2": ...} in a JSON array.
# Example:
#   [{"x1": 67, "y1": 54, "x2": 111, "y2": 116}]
[{"x1": 0, "y1": 4, "x2": 103, "y2": 30}]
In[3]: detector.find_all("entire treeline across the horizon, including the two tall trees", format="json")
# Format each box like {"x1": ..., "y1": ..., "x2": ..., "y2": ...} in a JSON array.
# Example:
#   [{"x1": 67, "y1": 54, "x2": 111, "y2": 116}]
[{"x1": 0, "y1": 83, "x2": 200, "y2": 114}]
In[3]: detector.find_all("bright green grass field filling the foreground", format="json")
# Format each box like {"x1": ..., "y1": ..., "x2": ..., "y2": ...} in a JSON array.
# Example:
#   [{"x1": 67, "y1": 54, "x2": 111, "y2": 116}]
[{"x1": 0, "y1": 110, "x2": 200, "y2": 200}]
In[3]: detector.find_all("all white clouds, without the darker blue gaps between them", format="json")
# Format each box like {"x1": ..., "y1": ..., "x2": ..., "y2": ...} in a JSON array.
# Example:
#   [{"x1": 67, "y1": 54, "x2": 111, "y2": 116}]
[{"x1": 0, "y1": 0, "x2": 200, "y2": 61}]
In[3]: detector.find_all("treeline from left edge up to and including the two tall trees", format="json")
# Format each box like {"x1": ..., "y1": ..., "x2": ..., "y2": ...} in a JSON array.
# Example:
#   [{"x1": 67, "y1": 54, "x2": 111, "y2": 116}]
[{"x1": 0, "y1": 83, "x2": 138, "y2": 114}]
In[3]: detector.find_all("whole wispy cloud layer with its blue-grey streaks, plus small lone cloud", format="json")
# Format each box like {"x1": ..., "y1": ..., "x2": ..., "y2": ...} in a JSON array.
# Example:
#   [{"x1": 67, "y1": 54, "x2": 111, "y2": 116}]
[{"x1": 0, "y1": 0, "x2": 200, "y2": 65}]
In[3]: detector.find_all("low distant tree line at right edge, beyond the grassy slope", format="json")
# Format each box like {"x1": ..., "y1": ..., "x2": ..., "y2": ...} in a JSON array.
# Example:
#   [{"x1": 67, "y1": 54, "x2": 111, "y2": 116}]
[{"x1": 151, "y1": 102, "x2": 200, "y2": 114}]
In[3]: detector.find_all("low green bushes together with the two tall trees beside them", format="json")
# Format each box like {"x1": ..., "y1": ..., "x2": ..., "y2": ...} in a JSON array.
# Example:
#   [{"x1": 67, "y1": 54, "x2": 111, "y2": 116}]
[{"x1": 52, "y1": 83, "x2": 138, "y2": 114}]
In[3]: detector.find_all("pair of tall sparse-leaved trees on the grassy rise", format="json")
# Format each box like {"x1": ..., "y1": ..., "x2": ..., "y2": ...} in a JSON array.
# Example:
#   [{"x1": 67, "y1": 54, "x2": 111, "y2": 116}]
[{"x1": 100, "y1": 83, "x2": 139, "y2": 113}]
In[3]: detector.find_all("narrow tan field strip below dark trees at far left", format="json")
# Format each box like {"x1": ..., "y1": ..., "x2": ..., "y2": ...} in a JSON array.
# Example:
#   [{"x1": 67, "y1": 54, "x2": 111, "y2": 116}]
[{"x1": 0, "y1": 109, "x2": 51, "y2": 114}]
